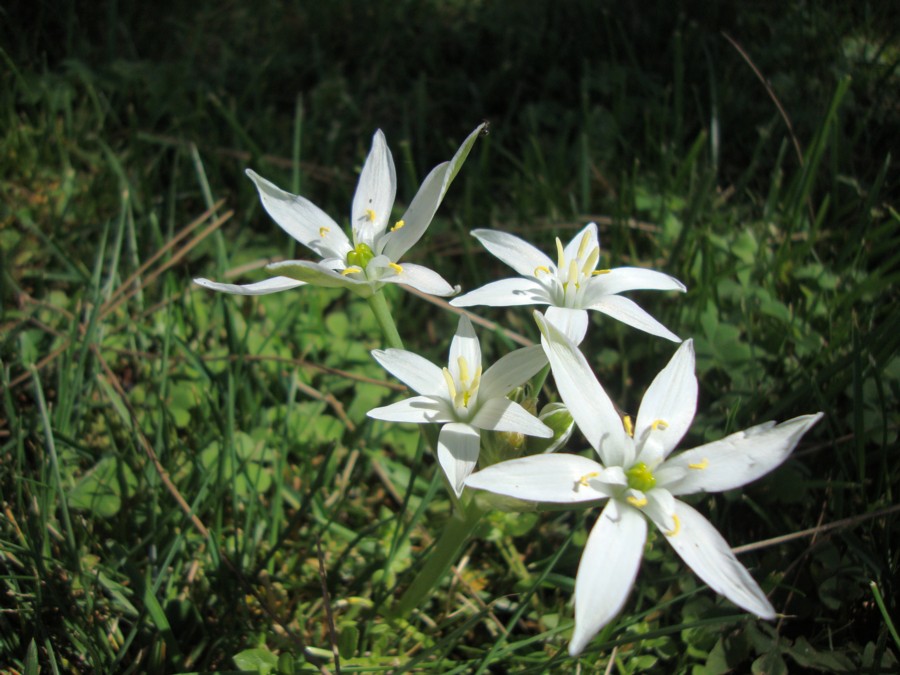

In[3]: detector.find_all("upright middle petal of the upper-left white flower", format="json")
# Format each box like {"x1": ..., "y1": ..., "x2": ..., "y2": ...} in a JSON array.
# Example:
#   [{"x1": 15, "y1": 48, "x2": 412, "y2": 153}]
[{"x1": 351, "y1": 129, "x2": 397, "y2": 247}]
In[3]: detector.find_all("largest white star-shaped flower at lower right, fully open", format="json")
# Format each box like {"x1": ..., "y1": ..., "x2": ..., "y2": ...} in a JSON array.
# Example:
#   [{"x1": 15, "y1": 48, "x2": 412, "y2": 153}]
[{"x1": 466, "y1": 312, "x2": 822, "y2": 656}]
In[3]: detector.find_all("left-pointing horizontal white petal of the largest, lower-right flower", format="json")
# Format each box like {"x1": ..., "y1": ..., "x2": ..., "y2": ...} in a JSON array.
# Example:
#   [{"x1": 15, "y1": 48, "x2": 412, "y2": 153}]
[{"x1": 466, "y1": 453, "x2": 609, "y2": 504}]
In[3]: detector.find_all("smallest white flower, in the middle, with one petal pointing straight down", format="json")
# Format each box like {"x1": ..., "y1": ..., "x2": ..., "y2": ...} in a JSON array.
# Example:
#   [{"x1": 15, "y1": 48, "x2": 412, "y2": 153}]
[{"x1": 368, "y1": 316, "x2": 553, "y2": 496}]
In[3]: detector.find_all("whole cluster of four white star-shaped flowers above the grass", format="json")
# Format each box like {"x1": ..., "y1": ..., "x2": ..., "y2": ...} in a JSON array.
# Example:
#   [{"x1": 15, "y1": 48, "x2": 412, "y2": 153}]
[{"x1": 196, "y1": 127, "x2": 822, "y2": 656}]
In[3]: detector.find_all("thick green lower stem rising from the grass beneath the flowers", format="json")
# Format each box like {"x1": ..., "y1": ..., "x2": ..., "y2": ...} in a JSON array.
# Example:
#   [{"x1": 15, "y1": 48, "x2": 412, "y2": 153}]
[{"x1": 391, "y1": 499, "x2": 485, "y2": 619}]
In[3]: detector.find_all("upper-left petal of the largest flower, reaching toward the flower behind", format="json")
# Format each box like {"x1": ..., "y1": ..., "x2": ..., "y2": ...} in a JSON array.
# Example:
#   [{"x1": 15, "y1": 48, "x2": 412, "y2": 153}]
[{"x1": 534, "y1": 312, "x2": 634, "y2": 466}]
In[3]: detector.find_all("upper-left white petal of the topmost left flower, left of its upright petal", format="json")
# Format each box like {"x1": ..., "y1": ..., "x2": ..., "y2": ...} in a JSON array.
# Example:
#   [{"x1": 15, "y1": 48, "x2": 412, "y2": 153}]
[{"x1": 246, "y1": 169, "x2": 352, "y2": 258}]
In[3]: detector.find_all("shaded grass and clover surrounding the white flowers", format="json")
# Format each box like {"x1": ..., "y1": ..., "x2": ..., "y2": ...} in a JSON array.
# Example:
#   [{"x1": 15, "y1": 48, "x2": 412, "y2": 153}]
[{"x1": 0, "y1": 0, "x2": 900, "y2": 674}]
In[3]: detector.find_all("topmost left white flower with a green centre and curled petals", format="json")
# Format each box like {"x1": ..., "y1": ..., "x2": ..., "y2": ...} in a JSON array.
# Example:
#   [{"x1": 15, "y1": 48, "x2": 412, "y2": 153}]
[{"x1": 194, "y1": 124, "x2": 484, "y2": 297}]
